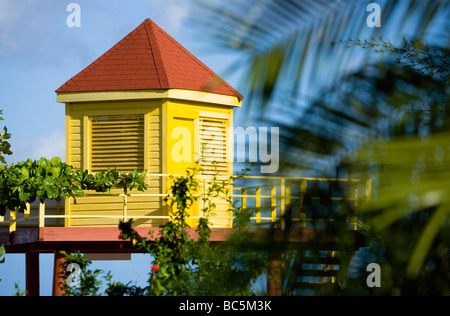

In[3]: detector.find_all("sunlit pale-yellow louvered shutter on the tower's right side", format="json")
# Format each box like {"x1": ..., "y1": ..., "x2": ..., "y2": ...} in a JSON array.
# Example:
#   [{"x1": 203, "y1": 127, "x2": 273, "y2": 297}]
[{"x1": 200, "y1": 119, "x2": 229, "y2": 175}]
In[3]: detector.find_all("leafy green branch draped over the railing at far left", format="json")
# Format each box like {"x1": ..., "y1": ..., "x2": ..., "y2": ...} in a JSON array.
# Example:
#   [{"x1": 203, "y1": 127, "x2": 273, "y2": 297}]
[{"x1": 0, "y1": 158, "x2": 146, "y2": 216}]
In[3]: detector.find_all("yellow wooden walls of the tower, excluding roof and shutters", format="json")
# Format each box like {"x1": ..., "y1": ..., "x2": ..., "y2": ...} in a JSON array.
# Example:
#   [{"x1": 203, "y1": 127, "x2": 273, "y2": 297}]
[{"x1": 65, "y1": 94, "x2": 237, "y2": 227}]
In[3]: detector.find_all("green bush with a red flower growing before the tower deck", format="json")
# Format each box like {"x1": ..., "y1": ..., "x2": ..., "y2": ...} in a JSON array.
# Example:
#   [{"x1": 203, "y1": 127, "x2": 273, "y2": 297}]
[{"x1": 58, "y1": 169, "x2": 267, "y2": 296}]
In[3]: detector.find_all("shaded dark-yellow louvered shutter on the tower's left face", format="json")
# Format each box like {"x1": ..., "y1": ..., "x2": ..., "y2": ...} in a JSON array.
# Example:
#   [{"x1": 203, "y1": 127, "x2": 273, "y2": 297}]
[{"x1": 90, "y1": 115, "x2": 144, "y2": 172}]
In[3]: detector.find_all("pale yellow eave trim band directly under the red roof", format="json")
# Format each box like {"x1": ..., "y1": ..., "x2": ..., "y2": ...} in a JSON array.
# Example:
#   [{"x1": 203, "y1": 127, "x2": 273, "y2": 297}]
[{"x1": 56, "y1": 89, "x2": 242, "y2": 107}]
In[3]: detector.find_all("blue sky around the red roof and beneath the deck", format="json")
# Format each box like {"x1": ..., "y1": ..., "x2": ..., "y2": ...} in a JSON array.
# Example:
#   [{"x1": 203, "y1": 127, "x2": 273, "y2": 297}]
[{"x1": 0, "y1": 0, "x2": 244, "y2": 295}]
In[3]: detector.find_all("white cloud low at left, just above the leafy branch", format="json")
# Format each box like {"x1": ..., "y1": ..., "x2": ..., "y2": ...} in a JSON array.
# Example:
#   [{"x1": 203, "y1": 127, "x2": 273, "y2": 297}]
[{"x1": 6, "y1": 130, "x2": 66, "y2": 163}]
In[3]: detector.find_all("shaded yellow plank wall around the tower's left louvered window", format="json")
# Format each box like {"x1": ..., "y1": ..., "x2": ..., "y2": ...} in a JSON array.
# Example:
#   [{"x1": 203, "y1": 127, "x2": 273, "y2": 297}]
[{"x1": 66, "y1": 101, "x2": 165, "y2": 226}]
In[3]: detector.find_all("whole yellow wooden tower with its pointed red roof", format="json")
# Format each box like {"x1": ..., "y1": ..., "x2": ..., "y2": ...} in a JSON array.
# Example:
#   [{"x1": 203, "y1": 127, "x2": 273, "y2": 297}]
[{"x1": 56, "y1": 19, "x2": 243, "y2": 227}]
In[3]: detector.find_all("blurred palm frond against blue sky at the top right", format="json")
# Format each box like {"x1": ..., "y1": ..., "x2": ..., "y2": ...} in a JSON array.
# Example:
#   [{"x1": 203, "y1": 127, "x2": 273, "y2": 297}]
[{"x1": 195, "y1": 0, "x2": 448, "y2": 117}]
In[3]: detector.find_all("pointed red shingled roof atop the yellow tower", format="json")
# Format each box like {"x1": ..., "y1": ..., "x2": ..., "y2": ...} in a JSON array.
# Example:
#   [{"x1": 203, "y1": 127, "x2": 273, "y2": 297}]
[{"x1": 56, "y1": 19, "x2": 243, "y2": 100}]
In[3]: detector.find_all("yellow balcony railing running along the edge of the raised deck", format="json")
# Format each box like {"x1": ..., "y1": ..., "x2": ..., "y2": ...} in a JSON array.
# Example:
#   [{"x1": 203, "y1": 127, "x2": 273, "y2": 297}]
[{"x1": 0, "y1": 174, "x2": 372, "y2": 232}]
